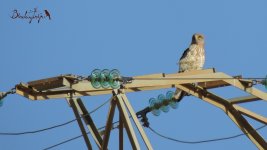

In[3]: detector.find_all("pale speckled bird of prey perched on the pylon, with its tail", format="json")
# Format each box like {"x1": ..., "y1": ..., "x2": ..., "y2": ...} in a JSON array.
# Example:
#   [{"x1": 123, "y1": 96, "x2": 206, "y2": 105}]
[{"x1": 174, "y1": 33, "x2": 205, "y2": 102}]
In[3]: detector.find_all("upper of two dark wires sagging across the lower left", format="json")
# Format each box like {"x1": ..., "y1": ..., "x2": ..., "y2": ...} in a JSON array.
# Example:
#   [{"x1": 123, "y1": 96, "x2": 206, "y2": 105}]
[{"x1": 0, "y1": 99, "x2": 111, "y2": 136}]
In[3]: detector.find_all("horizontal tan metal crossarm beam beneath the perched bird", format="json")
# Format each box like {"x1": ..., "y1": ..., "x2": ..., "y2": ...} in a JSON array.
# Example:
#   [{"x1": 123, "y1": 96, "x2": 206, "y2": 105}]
[{"x1": 16, "y1": 69, "x2": 264, "y2": 100}]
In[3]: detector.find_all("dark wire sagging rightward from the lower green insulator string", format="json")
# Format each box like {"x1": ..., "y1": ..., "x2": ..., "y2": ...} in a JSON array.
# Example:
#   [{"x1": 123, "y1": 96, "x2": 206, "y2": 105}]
[{"x1": 148, "y1": 125, "x2": 267, "y2": 144}]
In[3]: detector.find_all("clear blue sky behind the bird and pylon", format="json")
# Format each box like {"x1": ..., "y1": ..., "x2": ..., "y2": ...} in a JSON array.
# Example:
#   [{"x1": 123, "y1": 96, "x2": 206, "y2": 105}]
[{"x1": 0, "y1": 0, "x2": 267, "y2": 150}]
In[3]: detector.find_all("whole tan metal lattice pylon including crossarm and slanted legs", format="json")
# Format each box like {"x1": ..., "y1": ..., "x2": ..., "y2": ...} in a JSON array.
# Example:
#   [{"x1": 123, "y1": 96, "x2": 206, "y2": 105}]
[{"x1": 13, "y1": 69, "x2": 267, "y2": 149}]
